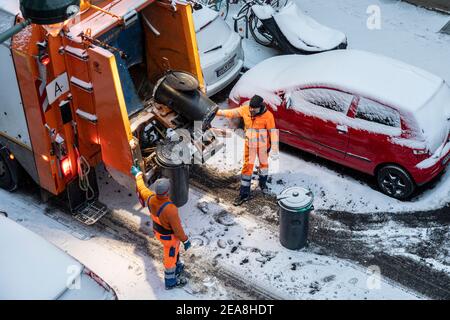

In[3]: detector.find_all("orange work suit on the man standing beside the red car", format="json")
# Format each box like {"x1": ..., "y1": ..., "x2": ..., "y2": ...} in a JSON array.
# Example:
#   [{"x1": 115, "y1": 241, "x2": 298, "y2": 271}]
[{"x1": 217, "y1": 105, "x2": 279, "y2": 195}]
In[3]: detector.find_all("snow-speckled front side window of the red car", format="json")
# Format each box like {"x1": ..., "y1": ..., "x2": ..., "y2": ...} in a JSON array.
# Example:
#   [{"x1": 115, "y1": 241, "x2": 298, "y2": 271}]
[{"x1": 292, "y1": 88, "x2": 353, "y2": 114}]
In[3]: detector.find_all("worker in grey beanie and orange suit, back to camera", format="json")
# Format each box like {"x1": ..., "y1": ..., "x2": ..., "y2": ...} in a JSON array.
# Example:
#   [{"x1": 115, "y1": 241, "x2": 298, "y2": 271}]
[{"x1": 131, "y1": 166, "x2": 191, "y2": 290}]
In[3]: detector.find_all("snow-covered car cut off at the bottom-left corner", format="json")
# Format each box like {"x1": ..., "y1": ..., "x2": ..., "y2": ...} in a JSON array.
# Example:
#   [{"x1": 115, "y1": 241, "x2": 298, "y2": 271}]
[{"x1": 0, "y1": 214, "x2": 117, "y2": 300}]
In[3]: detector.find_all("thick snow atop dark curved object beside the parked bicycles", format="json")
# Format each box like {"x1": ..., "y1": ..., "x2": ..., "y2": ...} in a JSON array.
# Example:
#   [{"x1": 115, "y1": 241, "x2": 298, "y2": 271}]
[{"x1": 252, "y1": 2, "x2": 346, "y2": 51}]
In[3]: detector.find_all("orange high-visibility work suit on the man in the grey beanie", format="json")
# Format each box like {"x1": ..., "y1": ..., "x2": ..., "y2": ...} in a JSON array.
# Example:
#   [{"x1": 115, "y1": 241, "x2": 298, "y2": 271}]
[{"x1": 136, "y1": 175, "x2": 188, "y2": 287}]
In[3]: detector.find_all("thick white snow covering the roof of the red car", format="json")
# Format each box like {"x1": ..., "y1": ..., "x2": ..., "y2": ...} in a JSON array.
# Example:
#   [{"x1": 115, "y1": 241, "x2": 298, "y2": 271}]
[{"x1": 230, "y1": 50, "x2": 444, "y2": 112}]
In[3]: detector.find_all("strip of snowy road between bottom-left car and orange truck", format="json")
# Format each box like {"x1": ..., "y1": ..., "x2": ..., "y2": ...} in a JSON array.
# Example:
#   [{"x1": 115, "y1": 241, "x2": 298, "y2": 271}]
[{"x1": 0, "y1": 190, "x2": 198, "y2": 299}]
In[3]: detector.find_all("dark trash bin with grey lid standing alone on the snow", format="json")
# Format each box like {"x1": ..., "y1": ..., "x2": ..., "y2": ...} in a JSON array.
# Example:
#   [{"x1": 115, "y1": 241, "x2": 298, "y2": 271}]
[{"x1": 277, "y1": 187, "x2": 314, "y2": 250}]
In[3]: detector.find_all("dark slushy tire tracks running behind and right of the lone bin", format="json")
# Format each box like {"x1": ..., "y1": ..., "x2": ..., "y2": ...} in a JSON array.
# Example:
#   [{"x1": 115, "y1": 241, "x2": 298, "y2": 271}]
[{"x1": 191, "y1": 167, "x2": 450, "y2": 299}]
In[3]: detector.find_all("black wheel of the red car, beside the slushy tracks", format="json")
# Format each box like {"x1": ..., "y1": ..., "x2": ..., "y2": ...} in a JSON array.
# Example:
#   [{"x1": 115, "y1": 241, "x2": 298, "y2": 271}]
[{"x1": 377, "y1": 165, "x2": 416, "y2": 200}]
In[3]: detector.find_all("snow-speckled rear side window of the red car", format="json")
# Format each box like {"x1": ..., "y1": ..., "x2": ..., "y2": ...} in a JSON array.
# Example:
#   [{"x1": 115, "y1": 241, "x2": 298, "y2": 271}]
[{"x1": 355, "y1": 98, "x2": 401, "y2": 128}]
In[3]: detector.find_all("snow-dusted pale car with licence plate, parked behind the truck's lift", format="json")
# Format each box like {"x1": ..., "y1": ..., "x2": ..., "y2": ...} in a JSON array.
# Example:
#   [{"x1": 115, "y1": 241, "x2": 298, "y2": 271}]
[{"x1": 193, "y1": 7, "x2": 244, "y2": 96}]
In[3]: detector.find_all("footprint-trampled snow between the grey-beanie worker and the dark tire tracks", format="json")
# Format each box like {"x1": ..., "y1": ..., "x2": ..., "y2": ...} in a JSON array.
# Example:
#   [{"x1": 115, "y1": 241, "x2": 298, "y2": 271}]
[{"x1": 96, "y1": 170, "x2": 422, "y2": 299}]
